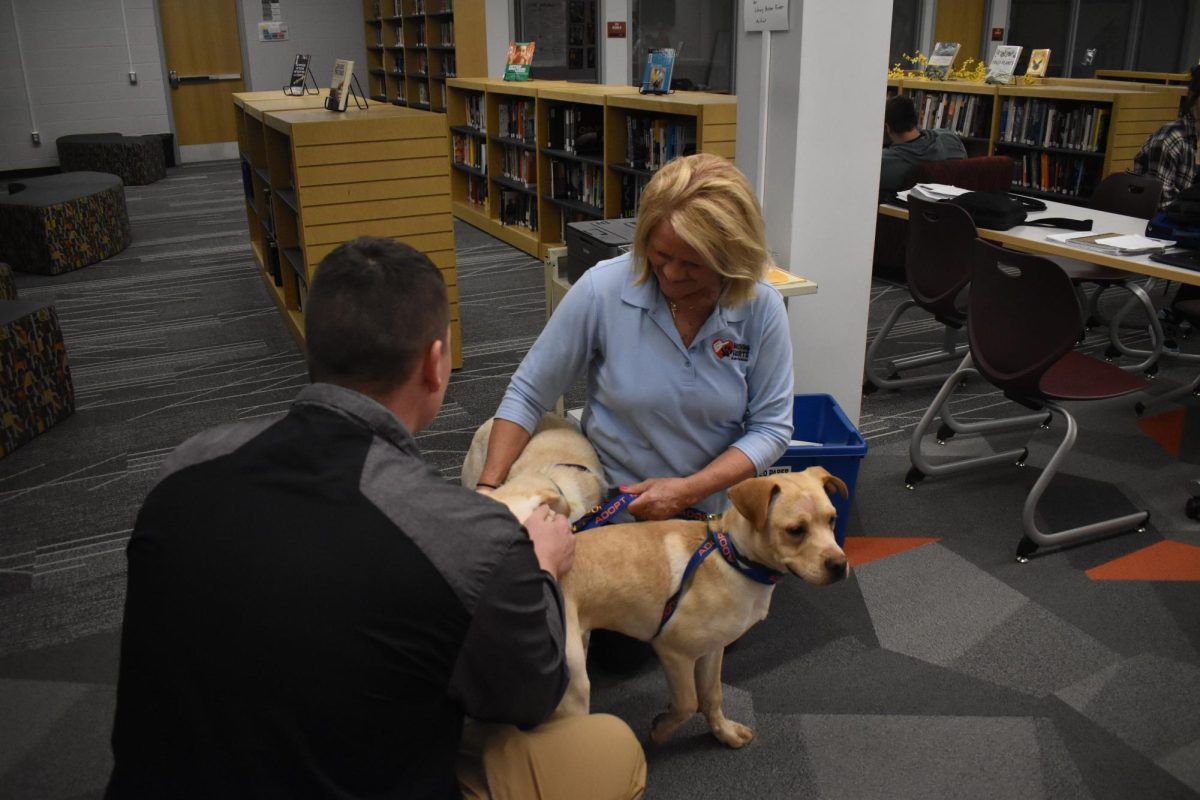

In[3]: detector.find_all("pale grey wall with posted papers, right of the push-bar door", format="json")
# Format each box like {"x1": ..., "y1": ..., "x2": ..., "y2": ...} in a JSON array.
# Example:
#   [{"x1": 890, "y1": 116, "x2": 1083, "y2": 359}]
[{"x1": 238, "y1": 0, "x2": 367, "y2": 91}]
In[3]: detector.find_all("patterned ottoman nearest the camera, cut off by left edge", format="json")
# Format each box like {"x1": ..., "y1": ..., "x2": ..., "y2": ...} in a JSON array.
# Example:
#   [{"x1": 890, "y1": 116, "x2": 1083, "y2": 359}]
[{"x1": 0, "y1": 264, "x2": 74, "y2": 458}]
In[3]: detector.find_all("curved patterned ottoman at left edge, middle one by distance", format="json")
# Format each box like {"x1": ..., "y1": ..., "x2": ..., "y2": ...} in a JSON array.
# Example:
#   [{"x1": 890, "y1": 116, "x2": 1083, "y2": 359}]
[{"x1": 0, "y1": 173, "x2": 130, "y2": 275}]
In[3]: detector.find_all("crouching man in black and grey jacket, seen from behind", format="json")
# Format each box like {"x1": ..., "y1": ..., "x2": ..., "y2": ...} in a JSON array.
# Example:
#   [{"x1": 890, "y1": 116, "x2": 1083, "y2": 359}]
[{"x1": 106, "y1": 239, "x2": 646, "y2": 800}]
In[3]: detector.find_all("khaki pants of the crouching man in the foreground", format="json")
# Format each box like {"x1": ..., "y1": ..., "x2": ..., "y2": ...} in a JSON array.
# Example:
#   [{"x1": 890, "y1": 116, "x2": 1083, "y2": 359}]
[{"x1": 458, "y1": 714, "x2": 646, "y2": 800}]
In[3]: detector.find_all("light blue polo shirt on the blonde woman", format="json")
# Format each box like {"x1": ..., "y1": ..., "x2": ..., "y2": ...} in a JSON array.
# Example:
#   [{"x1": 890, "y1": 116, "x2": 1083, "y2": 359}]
[{"x1": 496, "y1": 254, "x2": 793, "y2": 512}]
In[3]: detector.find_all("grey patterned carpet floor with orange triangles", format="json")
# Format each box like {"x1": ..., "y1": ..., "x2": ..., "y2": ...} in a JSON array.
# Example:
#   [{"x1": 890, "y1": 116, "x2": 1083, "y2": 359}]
[{"x1": 0, "y1": 163, "x2": 1200, "y2": 800}]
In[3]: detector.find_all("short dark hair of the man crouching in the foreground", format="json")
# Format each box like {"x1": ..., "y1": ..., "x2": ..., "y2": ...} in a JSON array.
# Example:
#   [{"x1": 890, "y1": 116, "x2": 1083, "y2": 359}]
[{"x1": 304, "y1": 236, "x2": 450, "y2": 395}]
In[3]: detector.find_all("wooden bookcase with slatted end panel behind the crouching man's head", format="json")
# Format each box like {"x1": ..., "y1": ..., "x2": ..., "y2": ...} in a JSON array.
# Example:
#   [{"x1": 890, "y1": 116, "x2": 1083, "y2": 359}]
[{"x1": 233, "y1": 91, "x2": 462, "y2": 368}]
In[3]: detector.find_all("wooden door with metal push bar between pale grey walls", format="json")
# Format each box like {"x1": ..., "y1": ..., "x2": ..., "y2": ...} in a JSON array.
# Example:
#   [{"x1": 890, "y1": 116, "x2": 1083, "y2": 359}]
[{"x1": 158, "y1": 0, "x2": 246, "y2": 151}]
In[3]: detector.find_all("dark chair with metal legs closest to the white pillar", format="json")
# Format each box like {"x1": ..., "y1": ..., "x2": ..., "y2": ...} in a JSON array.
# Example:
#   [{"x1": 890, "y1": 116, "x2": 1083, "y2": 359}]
[{"x1": 863, "y1": 197, "x2": 976, "y2": 395}]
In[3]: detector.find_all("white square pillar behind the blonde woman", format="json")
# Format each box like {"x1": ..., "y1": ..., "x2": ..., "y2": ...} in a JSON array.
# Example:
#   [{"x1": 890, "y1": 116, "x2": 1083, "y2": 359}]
[{"x1": 737, "y1": 0, "x2": 892, "y2": 423}]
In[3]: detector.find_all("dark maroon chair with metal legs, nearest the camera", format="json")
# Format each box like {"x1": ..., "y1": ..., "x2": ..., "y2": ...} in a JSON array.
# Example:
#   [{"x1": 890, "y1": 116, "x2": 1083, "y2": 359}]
[{"x1": 908, "y1": 240, "x2": 1150, "y2": 561}]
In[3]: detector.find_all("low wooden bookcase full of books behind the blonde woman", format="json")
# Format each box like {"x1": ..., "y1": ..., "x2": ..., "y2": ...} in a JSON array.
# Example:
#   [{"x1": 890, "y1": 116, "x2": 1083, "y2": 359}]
[{"x1": 446, "y1": 78, "x2": 737, "y2": 259}]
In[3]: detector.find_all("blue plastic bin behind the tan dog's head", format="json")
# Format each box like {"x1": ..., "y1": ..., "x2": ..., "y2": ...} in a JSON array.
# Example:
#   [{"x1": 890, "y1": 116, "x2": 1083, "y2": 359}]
[{"x1": 767, "y1": 395, "x2": 866, "y2": 546}]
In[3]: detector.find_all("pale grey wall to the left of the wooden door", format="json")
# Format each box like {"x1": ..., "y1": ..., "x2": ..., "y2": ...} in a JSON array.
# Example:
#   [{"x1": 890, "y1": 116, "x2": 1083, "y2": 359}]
[{"x1": 0, "y1": 0, "x2": 170, "y2": 172}]
